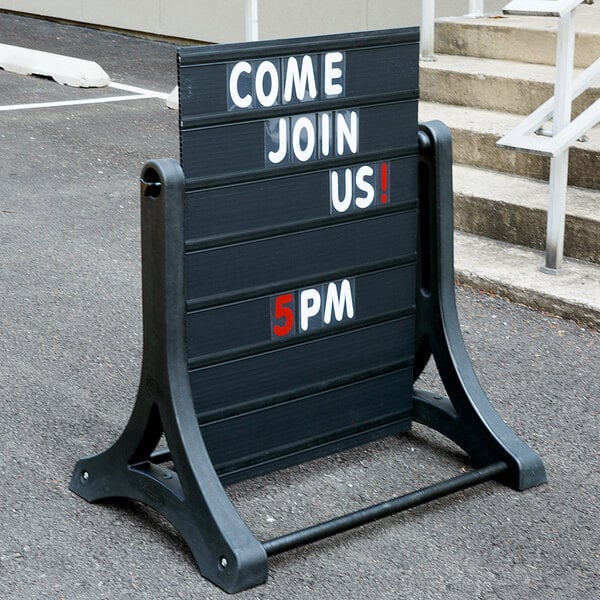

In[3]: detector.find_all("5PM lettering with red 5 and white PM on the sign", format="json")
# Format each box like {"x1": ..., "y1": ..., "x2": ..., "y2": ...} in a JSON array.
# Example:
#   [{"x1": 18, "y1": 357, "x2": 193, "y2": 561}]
[{"x1": 271, "y1": 279, "x2": 355, "y2": 338}]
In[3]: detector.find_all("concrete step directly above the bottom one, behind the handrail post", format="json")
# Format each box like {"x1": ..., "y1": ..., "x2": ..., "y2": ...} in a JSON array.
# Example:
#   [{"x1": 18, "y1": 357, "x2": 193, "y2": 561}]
[{"x1": 453, "y1": 165, "x2": 600, "y2": 264}]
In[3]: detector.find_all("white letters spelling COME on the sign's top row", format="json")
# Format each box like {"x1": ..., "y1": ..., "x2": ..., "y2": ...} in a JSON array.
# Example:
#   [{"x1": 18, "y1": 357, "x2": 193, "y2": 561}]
[{"x1": 227, "y1": 52, "x2": 345, "y2": 110}]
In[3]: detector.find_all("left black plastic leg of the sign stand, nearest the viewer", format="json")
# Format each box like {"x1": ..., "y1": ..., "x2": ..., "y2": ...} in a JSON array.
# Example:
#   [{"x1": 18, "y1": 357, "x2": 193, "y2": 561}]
[{"x1": 71, "y1": 160, "x2": 267, "y2": 592}]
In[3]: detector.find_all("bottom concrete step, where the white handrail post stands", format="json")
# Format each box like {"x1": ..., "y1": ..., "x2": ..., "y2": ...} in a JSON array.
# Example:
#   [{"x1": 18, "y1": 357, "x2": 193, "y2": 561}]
[{"x1": 454, "y1": 232, "x2": 600, "y2": 328}]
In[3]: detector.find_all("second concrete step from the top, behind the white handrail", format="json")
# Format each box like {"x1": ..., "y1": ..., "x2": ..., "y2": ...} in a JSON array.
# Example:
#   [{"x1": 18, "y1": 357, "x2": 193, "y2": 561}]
[{"x1": 420, "y1": 55, "x2": 600, "y2": 117}]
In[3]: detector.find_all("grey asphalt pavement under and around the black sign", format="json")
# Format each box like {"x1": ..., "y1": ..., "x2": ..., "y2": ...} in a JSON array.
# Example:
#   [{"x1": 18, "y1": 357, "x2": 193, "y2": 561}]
[{"x1": 0, "y1": 14, "x2": 600, "y2": 600}]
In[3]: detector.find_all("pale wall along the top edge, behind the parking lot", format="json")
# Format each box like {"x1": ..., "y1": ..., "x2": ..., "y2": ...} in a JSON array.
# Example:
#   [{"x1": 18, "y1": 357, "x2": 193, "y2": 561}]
[{"x1": 0, "y1": 0, "x2": 507, "y2": 42}]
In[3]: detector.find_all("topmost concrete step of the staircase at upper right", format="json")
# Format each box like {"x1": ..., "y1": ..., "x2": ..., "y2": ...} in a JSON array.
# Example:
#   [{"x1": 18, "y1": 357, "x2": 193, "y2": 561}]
[{"x1": 435, "y1": 3, "x2": 600, "y2": 67}]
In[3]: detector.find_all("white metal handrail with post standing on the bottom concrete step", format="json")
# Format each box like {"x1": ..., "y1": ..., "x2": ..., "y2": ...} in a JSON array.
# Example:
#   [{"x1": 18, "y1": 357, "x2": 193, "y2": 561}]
[{"x1": 497, "y1": 0, "x2": 600, "y2": 273}]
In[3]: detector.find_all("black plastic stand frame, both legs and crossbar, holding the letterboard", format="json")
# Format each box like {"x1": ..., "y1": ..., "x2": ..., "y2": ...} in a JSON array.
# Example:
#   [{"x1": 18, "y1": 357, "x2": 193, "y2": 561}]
[{"x1": 71, "y1": 32, "x2": 546, "y2": 592}]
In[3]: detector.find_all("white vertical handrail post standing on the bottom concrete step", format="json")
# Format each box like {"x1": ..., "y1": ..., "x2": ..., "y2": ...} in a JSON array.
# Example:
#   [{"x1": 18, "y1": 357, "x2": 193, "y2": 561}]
[{"x1": 542, "y1": 9, "x2": 575, "y2": 273}]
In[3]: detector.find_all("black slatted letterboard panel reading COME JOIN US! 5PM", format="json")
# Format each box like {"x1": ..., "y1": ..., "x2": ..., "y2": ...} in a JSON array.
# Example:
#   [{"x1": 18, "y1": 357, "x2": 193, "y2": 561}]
[{"x1": 179, "y1": 28, "x2": 418, "y2": 482}]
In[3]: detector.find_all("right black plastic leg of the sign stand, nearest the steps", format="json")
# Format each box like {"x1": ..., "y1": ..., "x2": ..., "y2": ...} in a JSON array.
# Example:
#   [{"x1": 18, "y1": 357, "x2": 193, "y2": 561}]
[{"x1": 413, "y1": 121, "x2": 546, "y2": 490}]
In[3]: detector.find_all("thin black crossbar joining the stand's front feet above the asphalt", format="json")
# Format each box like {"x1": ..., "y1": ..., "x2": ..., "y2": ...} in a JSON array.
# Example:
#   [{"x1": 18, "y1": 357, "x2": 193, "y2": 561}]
[{"x1": 262, "y1": 462, "x2": 508, "y2": 556}]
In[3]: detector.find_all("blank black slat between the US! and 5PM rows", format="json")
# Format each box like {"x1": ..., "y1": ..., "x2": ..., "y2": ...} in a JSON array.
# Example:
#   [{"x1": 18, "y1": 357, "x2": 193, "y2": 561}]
[{"x1": 186, "y1": 211, "x2": 416, "y2": 300}]
